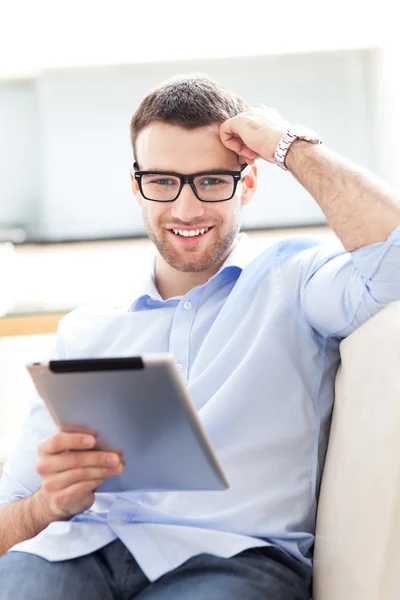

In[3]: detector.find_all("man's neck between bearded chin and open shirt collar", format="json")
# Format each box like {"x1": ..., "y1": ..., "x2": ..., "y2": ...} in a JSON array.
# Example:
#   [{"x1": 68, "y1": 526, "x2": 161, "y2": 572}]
[{"x1": 155, "y1": 243, "x2": 236, "y2": 300}]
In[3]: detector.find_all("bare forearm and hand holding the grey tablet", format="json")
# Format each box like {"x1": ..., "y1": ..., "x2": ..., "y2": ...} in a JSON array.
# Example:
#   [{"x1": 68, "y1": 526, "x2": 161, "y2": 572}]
[{"x1": 0, "y1": 432, "x2": 124, "y2": 556}]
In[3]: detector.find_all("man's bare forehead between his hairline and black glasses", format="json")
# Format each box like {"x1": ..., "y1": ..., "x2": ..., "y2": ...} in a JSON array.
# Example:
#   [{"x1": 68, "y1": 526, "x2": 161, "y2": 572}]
[{"x1": 136, "y1": 122, "x2": 239, "y2": 172}]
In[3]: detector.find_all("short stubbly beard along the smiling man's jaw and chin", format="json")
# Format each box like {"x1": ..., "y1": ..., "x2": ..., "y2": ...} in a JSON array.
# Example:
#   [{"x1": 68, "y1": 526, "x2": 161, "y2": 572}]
[{"x1": 143, "y1": 204, "x2": 242, "y2": 273}]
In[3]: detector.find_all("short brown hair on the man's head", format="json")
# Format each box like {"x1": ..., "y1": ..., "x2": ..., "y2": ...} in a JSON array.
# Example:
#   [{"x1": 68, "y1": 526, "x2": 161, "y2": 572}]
[{"x1": 130, "y1": 75, "x2": 247, "y2": 162}]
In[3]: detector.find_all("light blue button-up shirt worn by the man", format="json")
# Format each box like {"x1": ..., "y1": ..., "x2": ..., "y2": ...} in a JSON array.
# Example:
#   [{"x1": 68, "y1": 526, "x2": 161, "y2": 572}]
[{"x1": 0, "y1": 227, "x2": 400, "y2": 580}]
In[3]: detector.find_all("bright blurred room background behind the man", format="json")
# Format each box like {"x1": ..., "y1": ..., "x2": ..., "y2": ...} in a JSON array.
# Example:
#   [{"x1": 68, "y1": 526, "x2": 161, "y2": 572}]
[{"x1": 0, "y1": 0, "x2": 400, "y2": 455}]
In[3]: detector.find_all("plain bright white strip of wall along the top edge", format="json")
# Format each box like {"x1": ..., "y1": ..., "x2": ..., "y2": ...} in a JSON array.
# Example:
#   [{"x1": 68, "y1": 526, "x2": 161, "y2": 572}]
[{"x1": 0, "y1": 0, "x2": 388, "y2": 78}]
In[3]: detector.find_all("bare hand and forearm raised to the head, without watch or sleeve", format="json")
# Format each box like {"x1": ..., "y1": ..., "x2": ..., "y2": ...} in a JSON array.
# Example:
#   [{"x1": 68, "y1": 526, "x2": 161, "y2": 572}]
[{"x1": 219, "y1": 105, "x2": 400, "y2": 252}]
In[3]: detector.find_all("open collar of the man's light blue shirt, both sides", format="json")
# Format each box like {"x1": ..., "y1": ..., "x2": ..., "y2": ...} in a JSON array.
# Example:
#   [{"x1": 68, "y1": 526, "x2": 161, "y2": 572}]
[{"x1": 127, "y1": 233, "x2": 254, "y2": 312}]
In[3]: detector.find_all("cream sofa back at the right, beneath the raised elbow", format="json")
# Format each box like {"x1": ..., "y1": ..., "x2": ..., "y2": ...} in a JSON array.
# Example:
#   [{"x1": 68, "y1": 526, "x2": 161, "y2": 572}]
[{"x1": 314, "y1": 302, "x2": 400, "y2": 600}]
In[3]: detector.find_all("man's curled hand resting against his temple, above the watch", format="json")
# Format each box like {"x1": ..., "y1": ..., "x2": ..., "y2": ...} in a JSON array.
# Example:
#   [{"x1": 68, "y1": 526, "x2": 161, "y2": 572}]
[{"x1": 219, "y1": 104, "x2": 289, "y2": 165}]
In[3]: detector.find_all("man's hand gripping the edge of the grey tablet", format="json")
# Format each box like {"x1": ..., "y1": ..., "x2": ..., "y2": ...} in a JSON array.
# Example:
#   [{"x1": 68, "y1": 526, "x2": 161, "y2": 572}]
[{"x1": 36, "y1": 432, "x2": 124, "y2": 520}]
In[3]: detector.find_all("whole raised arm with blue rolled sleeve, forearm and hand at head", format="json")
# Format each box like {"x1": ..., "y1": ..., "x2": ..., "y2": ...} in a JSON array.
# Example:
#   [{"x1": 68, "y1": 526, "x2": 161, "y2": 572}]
[{"x1": 219, "y1": 105, "x2": 400, "y2": 338}]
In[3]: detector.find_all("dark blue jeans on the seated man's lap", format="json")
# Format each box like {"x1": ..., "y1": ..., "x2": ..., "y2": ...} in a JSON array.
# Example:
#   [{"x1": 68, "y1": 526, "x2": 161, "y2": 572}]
[{"x1": 0, "y1": 540, "x2": 311, "y2": 600}]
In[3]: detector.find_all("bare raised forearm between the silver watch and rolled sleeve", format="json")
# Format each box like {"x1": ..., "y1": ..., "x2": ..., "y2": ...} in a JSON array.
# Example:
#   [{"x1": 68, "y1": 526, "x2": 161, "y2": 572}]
[{"x1": 286, "y1": 141, "x2": 400, "y2": 252}]
